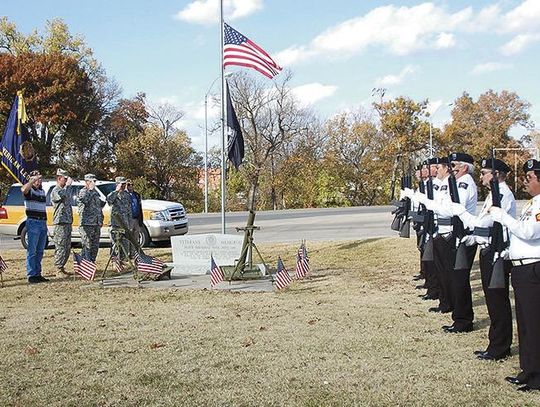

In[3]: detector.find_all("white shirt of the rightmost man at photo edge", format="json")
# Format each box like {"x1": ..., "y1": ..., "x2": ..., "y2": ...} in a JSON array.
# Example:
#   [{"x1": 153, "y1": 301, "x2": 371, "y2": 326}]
[{"x1": 502, "y1": 195, "x2": 540, "y2": 261}]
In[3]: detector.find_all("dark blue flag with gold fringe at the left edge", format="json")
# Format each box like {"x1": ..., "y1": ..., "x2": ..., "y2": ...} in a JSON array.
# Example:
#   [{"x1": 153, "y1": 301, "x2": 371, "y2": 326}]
[{"x1": 0, "y1": 92, "x2": 37, "y2": 184}]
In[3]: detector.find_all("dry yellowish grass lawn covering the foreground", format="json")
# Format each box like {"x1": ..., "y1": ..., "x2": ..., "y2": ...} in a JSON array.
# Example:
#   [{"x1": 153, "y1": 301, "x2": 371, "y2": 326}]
[{"x1": 0, "y1": 239, "x2": 540, "y2": 406}]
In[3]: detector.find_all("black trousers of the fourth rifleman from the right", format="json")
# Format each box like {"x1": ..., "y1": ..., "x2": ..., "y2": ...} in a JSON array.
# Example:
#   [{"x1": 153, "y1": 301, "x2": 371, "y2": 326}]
[{"x1": 433, "y1": 235, "x2": 456, "y2": 312}]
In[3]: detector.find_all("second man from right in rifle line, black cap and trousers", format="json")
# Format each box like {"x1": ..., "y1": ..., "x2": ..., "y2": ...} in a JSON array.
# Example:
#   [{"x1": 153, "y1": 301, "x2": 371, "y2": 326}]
[{"x1": 452, "y1": 158, "x2": 516, "y2": 360}]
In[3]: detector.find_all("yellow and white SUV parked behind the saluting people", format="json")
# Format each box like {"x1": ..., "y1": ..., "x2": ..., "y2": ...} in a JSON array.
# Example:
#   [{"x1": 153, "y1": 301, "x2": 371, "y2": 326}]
[{"x1": 0, "y1": 181, "x2": 188, "y2": 248}]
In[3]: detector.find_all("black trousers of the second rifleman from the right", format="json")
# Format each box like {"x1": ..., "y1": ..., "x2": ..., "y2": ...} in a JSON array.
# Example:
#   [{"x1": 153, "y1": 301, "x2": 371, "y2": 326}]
[{"x1": 480, "y1": 248, "x2": 512, "y2": 357}]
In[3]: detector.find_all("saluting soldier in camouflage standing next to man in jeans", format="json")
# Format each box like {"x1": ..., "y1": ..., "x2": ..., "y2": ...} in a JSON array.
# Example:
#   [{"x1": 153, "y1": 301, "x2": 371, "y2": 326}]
[{"x1": 51, "y1": 168, "x2": 73, "y2": 277}]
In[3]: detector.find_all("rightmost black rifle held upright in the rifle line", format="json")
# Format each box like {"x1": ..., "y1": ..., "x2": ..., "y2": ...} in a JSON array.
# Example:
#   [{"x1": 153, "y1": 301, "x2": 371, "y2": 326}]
[{"x1": 488, "y1": 163, "x2": 507, "y2": 288}]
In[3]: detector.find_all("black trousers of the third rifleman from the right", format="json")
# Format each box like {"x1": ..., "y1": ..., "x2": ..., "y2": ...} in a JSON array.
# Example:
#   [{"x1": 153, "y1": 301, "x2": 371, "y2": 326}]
[{"x1": 452, "y1": 245, "x2": 478, "y2": 329}]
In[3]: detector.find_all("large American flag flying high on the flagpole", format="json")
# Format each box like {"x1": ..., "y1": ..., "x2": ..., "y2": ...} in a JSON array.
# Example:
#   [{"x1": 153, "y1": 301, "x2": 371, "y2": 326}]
[{"x1": 223, "y1": 23, "x2": 282, "y2": 79}]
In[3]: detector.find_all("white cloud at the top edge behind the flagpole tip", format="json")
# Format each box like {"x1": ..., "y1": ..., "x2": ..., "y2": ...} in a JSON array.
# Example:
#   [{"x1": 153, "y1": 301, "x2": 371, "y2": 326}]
[{"x1": 174, "y1": 0, "x2": 263, "y2": 24}]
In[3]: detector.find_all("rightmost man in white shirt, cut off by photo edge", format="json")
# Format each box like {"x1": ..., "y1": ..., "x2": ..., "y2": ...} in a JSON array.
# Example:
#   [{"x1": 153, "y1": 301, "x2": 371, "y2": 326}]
[{"x1": 489, "y1": 160, "x2": 540, "y2": 391}]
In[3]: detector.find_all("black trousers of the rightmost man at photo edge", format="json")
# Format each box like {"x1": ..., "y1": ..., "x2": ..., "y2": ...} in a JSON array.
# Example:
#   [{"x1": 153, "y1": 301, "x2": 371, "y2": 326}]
[{"x1": 512, "y1": 262, "x2": 540, "y2": 389}]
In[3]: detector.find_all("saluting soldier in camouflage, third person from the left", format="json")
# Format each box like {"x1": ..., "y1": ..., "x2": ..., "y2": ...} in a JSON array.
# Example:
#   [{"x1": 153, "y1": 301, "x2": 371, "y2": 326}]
[{"x1": 78, "y1": 174, "x2": 103, "y2": 262}]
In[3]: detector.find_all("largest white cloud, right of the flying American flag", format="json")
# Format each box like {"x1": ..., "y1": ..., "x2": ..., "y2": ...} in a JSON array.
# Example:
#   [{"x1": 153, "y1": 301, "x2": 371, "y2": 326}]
[{"x1": 279, "y1": 3, "x2": 472, "y2": 64}]
